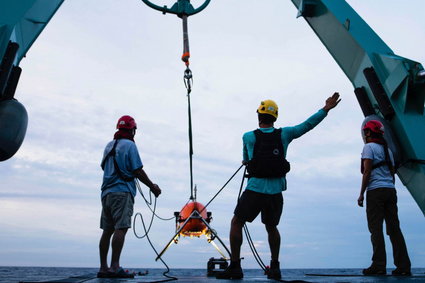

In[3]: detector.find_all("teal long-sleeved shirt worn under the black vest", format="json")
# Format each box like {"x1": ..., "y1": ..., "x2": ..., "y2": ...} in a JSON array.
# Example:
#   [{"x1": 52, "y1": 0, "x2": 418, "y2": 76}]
[{"x1": 242, "y1": 109, "x2": 327, "y2": 194}]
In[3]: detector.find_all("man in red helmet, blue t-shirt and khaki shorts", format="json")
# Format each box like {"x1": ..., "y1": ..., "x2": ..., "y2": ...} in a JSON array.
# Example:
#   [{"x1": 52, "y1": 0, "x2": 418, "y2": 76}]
[{"x1": 97, "y1": 115, "x2": 161, "y2": 278}]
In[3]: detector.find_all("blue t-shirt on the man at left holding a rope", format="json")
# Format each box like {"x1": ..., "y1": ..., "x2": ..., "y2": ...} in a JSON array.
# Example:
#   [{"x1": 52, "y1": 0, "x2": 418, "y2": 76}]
[{"x1": 101, "y1": 139, "x2": 143, "y2": 198}]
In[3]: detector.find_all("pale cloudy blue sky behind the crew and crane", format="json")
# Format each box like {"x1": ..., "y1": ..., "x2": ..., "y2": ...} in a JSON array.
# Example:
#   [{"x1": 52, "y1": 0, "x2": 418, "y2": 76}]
[{"x1": 0, "y1": 0, "x2": 425, "y2": 269}]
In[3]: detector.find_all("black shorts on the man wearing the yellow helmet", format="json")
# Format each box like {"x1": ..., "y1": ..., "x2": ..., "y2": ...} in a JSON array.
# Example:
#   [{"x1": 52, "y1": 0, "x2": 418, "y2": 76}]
[{"x1": 234, "y1": 190, "x2": 283, "y2": 226}]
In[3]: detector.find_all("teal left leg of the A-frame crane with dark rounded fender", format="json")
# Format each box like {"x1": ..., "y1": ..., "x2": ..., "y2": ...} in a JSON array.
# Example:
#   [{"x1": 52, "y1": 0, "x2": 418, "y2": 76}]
[{"x1": 0, "y1": 0, "x2": 64, "y2": 161}]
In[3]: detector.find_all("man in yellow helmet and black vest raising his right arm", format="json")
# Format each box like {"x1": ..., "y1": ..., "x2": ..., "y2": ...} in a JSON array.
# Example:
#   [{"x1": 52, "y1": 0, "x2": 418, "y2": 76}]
[{"x1": 217, "y1": 93, "x2": 340, "y2": 279}]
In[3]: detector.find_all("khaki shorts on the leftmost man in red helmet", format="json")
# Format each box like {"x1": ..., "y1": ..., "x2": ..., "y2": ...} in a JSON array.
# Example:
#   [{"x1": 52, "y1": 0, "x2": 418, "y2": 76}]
[{"x1": 100, "y1": 192, "x2": 134, "y2": 231}]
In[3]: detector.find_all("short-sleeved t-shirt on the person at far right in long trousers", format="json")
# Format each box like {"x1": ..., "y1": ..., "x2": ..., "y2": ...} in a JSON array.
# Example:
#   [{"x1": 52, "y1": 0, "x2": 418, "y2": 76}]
[{"x1": 362, "y1": 142, "x2": 395, "y2": 191}]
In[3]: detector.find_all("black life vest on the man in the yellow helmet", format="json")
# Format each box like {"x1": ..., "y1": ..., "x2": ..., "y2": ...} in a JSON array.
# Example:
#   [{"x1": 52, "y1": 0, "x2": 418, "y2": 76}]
[{"x1": 243, "y1": 129, "x2": 290, "y2": 178}]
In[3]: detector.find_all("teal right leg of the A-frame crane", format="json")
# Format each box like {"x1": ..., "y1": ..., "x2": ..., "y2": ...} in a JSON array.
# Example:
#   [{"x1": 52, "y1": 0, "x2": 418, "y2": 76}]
[{"x1": 291, "y1": 0, "x2": 425, "y2": 215}]
